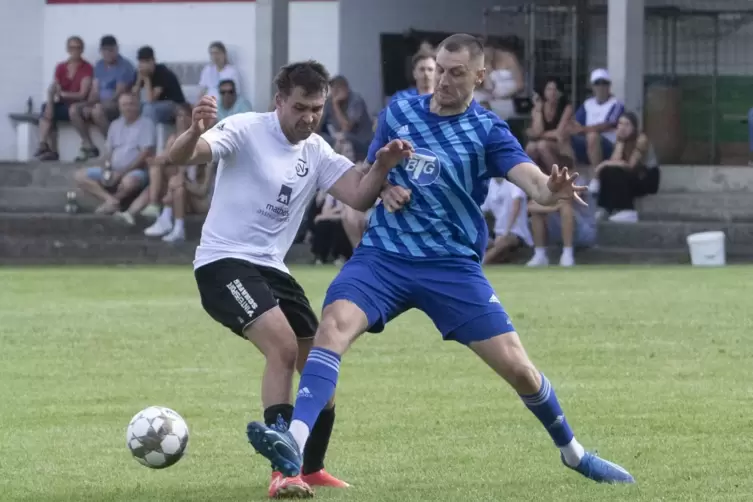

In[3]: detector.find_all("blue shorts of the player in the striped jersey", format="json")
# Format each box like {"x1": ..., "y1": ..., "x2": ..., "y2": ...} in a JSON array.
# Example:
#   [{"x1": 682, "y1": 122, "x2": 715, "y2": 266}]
[{"x1": 324, "y1": 246, "x2": 515, "y2": 345}]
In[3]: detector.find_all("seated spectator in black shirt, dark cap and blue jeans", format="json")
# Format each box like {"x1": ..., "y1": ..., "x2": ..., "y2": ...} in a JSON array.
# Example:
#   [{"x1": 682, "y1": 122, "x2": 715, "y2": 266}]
[{"x1": 133, "y1": 46, "x2": 186, "y2": 124}]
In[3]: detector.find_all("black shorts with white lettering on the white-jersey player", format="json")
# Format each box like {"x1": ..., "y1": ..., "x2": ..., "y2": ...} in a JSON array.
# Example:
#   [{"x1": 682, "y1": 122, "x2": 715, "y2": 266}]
[{"x1": 194, "y1": 258, "x2": 319, "y2": 339}]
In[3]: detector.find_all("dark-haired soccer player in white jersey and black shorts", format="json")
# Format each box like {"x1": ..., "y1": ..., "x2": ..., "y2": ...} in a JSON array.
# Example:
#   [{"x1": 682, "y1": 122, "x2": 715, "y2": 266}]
[{"x1": 170, "y1": 61, "x2": 412, "y2": 498}]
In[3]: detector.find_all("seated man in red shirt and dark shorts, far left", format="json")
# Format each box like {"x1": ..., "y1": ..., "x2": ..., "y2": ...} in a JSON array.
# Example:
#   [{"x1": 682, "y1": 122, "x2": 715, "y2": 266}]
[{"x1": 35, "y1": 36, "x2": 94, "y2": 160}]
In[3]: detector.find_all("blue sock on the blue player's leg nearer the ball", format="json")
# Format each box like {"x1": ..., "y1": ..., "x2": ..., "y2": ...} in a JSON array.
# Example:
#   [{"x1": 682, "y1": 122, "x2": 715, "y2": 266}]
[{"x1": 293, "y1": 347, "x2": 340, "y2": 431}]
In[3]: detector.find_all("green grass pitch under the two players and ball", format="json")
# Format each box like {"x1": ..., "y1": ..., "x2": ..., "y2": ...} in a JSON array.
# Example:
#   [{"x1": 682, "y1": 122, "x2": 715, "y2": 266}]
[{"x1": 0, "y1": 267, "x2": 753, "y2": 502}]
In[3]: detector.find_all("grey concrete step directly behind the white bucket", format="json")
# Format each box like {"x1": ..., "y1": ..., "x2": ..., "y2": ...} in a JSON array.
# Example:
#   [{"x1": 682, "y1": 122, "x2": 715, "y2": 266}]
[{"x1": 597, "y1": 221, "x2": 753, "y2": 252}]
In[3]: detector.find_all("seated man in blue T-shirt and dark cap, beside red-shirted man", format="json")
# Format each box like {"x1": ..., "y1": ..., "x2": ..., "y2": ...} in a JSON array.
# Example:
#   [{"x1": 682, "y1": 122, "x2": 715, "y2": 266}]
[{"x1": 70, "y1": 35, "x2": 136, "y2": 162}]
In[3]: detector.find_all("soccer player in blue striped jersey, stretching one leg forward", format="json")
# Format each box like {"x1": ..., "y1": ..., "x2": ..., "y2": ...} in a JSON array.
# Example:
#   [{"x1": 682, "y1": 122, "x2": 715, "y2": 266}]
[{"x1": 247, "y1": 34, "x2": 634, "y2": 483}]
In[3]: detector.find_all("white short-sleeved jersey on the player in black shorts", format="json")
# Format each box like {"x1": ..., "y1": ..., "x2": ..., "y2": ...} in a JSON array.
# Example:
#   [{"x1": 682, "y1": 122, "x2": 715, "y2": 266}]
[{"x1": 194, "y1": 112, "x2": 353, "y2": 273}]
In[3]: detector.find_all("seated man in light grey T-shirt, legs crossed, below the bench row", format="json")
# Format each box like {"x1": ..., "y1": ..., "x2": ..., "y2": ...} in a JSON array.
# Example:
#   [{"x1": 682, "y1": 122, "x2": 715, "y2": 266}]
[{"x1": 75, "y1": 94, "x2": 157, "y2": 214}]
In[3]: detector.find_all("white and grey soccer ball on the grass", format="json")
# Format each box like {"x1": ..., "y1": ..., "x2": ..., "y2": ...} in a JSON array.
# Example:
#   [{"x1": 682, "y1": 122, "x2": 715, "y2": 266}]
[{"x1": 126, "y1": 406, "x2": 188, "y2": 469}]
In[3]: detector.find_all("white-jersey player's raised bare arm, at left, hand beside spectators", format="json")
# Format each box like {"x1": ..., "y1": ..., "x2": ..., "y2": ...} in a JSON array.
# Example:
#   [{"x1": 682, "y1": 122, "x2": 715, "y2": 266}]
[{"x1": 168, "y1": 96, "x2": 217, "y2": 166}]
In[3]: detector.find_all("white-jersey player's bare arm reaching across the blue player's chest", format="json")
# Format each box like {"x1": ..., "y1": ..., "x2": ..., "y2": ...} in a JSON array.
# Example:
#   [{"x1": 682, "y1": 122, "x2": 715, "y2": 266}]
[{"x1": 329, "y1": 139, "x2": 413, "y2": 211}]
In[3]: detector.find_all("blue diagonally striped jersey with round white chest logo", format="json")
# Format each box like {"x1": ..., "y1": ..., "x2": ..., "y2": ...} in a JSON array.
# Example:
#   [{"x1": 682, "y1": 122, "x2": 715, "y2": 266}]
[{"x1": 361, "y1": 95, "x2": 531, "y2": 260}]
